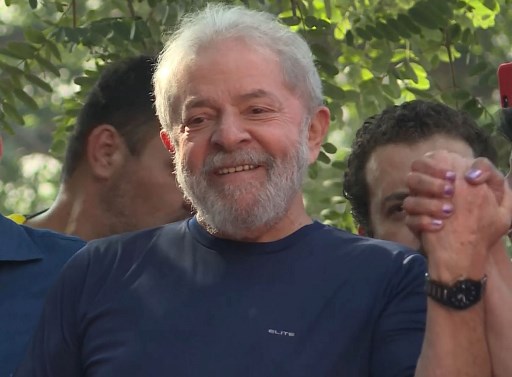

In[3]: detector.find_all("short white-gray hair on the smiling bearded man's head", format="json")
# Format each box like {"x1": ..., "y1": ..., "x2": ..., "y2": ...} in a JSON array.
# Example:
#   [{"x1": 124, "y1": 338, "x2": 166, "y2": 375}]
[{"x1": 153, "y1": 4, "x2": 323, "y2": 131}]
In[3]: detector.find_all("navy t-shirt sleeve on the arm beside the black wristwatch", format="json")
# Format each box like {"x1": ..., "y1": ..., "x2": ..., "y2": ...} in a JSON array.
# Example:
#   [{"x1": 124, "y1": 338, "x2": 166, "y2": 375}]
[{"x1": 371, "y1": 255, "x2": 427, "y2": 377}]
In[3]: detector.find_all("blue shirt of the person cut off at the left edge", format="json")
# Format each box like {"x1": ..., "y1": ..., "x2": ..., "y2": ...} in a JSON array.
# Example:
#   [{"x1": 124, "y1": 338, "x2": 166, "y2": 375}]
[{"x1": 0, "y1": 215, "x2": 85, "y2": 377}]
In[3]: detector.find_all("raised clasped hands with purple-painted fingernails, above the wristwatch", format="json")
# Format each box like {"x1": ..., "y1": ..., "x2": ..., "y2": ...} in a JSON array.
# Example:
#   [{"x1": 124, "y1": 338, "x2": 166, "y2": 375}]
[{"x1": 404, "y1": 151, "x2": 512, "y2": 277}]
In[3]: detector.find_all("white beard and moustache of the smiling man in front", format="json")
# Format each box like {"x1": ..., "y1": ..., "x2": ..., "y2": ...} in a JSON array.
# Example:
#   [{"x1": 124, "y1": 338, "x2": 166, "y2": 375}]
[{"x1": 174, "y1": 128, "x2": 309, "y2": 235}]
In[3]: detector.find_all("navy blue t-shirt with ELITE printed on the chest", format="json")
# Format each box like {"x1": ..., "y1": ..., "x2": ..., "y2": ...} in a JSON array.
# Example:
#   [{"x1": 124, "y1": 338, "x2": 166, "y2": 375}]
[{"x1": 16, "y1": 219, "x2": 426, "y2": 377}]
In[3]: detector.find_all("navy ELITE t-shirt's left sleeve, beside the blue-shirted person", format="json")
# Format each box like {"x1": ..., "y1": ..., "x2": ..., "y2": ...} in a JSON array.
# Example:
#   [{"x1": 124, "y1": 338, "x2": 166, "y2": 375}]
[{"x1": 14, "y1": 246, "x2": 89, "y2": 377}]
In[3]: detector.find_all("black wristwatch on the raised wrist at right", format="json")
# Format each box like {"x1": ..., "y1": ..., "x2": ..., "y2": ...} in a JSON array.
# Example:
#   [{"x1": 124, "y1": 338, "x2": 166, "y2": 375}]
[{"x1": 425, "y1": 273, "x2": 487, "y2": 310}]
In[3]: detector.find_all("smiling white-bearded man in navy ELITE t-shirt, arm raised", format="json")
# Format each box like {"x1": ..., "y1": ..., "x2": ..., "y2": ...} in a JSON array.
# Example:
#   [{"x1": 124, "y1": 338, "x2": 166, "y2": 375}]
[{"x1": 13, "y1": 5, "x2": 500, "y2": 377}]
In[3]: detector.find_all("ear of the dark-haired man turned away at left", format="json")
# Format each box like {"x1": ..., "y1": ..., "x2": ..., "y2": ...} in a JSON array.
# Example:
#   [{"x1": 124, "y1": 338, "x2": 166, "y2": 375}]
[{"x1": 86, "y1": 124, "x2": 125, "y2": 178}]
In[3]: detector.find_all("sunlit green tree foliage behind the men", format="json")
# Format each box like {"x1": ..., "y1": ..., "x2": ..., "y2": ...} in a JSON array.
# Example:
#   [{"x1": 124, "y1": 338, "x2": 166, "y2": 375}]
[{"x1": 0, "y1": 0, "x2": 512, "y2": 230}]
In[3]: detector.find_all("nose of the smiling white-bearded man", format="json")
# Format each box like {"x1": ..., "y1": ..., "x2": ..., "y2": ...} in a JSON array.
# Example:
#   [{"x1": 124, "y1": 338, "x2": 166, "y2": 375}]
[{"x1": 211, "y1": 114, "x2": 250, "y2": 151}]
